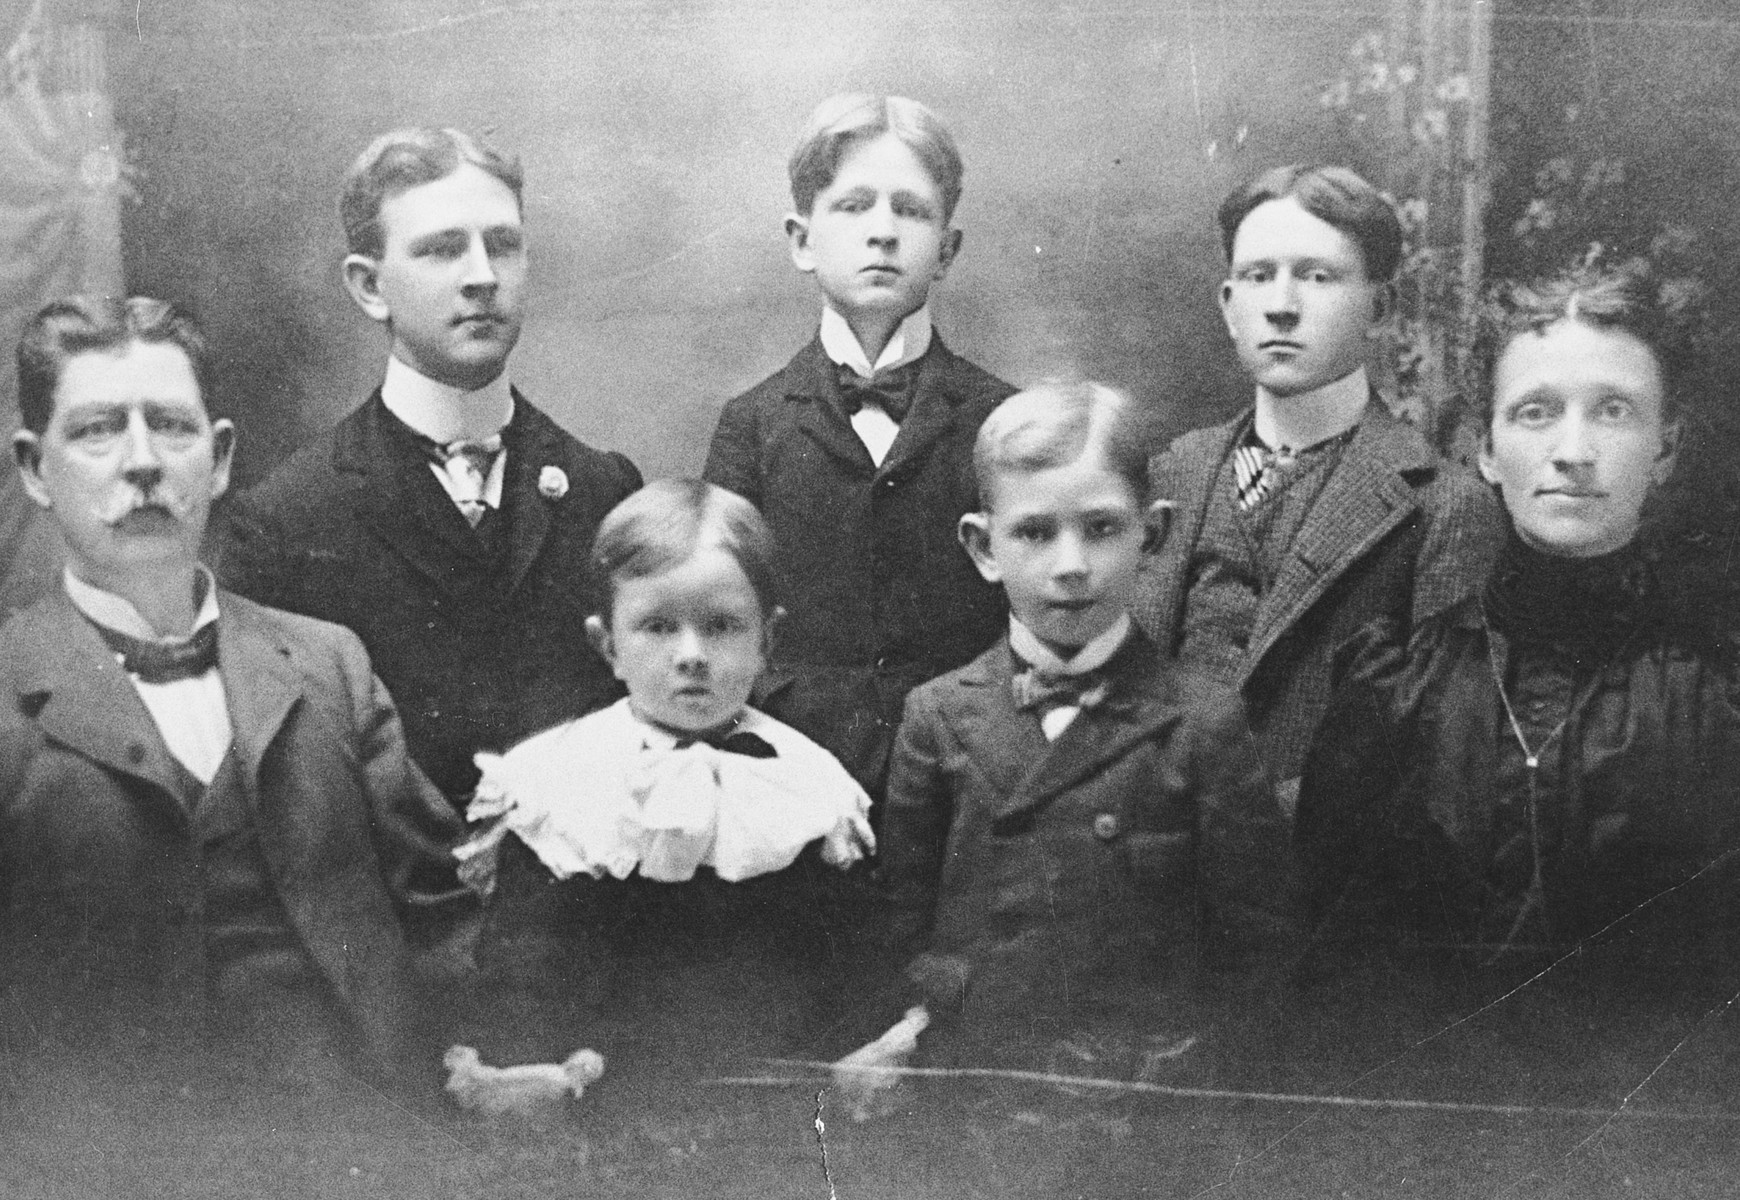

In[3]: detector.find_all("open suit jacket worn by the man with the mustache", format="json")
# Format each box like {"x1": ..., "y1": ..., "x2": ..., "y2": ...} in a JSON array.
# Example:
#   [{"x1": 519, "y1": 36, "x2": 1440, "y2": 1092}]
[{"x1": 0, "y1": 588, "x2": 475, "y2": 1068}]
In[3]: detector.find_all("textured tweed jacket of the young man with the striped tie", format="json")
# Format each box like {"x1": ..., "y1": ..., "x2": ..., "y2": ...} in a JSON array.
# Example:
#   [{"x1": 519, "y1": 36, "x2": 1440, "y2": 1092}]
[{"x1": 1134, "y1": 397, "x2": 1505, "y2": 783}]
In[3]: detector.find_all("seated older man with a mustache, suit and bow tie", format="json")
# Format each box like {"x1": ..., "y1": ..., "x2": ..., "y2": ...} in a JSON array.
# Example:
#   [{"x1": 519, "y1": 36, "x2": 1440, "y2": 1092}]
[{"x1": 0, "y1": 297, "x2": 475, "y2": 1096}]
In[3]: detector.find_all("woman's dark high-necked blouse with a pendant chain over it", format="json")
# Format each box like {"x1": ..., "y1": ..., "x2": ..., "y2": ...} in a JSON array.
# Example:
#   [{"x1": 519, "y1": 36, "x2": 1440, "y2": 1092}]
[{"x1": 1296, "y1": 536, "x2": 1740, "y2": 953}]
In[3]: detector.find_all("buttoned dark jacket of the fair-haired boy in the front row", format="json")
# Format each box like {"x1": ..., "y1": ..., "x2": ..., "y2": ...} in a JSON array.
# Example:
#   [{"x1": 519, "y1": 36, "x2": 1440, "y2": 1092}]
[{"x1": 880, "y1": 635, "x2": 1291, "y2": 1030}]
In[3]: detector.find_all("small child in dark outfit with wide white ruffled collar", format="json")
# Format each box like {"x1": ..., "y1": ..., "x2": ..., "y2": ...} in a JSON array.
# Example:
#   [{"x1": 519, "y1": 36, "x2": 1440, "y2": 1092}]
[{"x1": 461, "y1": 480, "x2": 875, "y2": 1061}]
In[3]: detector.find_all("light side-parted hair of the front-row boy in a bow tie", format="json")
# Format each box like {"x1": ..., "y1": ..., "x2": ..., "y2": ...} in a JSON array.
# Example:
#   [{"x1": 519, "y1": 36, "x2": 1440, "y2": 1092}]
[{"x1": 973, "y1": 383, "x2": 1148, "y2": 513}]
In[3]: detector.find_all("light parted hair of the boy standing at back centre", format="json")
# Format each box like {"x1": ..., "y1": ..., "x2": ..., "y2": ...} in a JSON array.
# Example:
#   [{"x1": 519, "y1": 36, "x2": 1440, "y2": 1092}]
[{"x1": 786, "y1": 92, "x2": 966, "y2": 224}]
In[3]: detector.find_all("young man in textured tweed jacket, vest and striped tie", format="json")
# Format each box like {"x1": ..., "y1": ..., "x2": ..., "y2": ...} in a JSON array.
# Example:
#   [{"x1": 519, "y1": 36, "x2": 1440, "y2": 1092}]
[{"x1": 1134, "y1": 165, "x2": 1502, "y2": 807}]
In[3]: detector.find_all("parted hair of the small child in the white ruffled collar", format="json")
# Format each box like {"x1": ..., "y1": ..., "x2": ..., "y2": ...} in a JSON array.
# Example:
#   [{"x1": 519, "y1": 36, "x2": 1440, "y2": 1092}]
[{"x1": 592, "y1": 478, "x2": 778, "y2": 623}]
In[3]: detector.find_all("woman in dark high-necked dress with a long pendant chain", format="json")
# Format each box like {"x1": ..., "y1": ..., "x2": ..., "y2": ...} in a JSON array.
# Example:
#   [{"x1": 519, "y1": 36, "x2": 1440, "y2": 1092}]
[{"x1": 1296, "y1": 263, "x2": 1740, "y2": 986}]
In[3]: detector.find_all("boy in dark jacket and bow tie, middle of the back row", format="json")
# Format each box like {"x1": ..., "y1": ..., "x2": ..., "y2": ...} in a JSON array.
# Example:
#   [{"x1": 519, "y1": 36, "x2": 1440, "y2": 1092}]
[{"x1": 705, "y1": 94, "x2": 1013, "y2": 798}]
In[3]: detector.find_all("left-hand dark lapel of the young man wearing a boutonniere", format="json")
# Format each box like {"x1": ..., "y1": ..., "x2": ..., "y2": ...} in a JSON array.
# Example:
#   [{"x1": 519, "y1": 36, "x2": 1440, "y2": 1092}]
[{"x1": 332, "y1": 390, "x2": 480, "y2": 593}]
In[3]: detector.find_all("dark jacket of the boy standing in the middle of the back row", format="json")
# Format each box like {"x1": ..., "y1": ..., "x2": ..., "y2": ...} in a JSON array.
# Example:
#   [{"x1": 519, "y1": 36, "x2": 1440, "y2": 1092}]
[{"x1": 705, "y1": 337, "x2": 1014, "y2": 795}]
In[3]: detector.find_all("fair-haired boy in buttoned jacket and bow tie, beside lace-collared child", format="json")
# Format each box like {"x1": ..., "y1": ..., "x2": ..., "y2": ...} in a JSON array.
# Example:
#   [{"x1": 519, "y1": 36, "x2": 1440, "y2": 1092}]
[{"x1": 842, "y1": 383, "x2": 1286, "y2": 1090}]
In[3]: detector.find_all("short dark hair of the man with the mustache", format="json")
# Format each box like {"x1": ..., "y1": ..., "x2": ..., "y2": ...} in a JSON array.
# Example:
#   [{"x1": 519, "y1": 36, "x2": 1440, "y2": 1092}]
[{"x1": 17, "y1": 296, "x2": 211, "y2": 437}]
